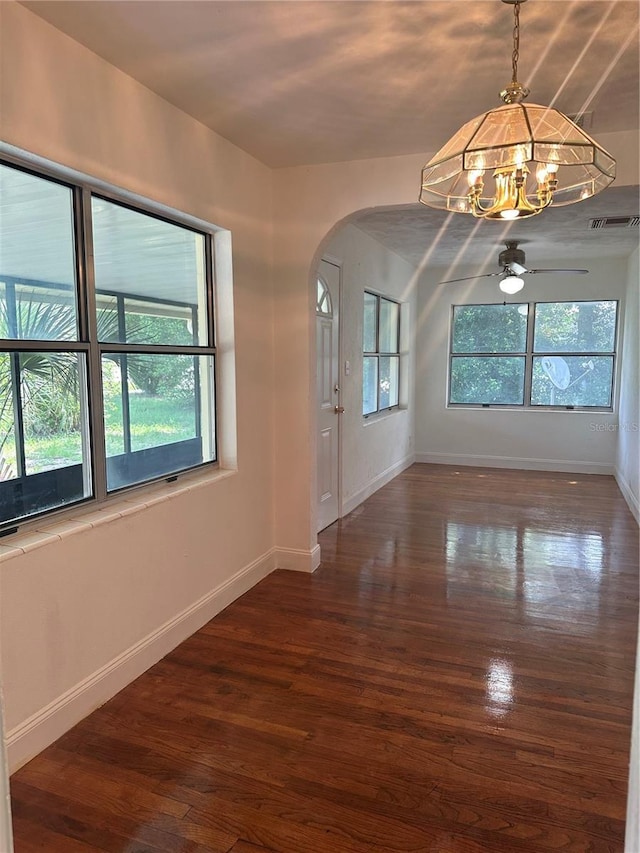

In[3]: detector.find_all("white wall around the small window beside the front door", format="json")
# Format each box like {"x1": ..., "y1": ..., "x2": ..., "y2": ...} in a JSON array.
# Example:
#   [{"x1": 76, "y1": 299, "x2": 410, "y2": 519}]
[{"x1": 324, "y1": 225, "x2": 417, "y2": 514}]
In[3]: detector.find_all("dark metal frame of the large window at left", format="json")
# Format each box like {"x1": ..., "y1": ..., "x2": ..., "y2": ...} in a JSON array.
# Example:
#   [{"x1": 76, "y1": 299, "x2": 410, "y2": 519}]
[{"x1": 0, "y1": 152, "x2": 220, "y2": 537}]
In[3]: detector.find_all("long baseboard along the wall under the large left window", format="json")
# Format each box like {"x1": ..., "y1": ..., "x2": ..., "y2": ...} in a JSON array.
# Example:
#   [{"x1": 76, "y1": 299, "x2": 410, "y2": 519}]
[{"x1": 6, "y1": 549, "x2": 276, "y2": 773}]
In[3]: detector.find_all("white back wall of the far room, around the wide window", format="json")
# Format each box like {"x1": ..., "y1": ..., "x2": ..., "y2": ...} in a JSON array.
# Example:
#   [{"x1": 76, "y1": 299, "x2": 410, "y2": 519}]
[{"x1": 416, "y1": 258, "x2": 627, "y2": 474}]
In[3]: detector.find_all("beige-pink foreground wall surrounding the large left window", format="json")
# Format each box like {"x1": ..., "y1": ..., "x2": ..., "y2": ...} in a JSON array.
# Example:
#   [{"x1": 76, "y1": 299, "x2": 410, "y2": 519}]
[{"x1": 0, "y1": 3, "x2": 275, "y2": 766}]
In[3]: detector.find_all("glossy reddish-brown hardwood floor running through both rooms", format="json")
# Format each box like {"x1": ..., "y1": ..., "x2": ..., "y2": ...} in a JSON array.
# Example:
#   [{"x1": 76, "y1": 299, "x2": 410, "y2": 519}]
[{"x1": 12, "y1": 465, "x2": 638, "y2": 853}]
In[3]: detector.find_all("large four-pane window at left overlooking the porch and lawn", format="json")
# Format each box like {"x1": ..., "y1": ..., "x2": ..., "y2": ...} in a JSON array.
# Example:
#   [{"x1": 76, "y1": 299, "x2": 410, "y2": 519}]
[{"x1": 0, "y1": 163, "x2": 216, "y2": 529}]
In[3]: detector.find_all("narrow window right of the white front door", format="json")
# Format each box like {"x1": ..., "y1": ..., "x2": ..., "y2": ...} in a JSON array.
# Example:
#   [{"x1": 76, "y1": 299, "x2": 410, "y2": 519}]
[{"x1": 362, "y1": 291, "x2": 400, "y2": 416}]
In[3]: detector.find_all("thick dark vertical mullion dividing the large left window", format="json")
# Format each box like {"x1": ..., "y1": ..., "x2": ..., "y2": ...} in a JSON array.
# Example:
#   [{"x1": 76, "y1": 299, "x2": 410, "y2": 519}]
[{"x1": 78, "y1": 187, "x2": 107, "y2": 500}]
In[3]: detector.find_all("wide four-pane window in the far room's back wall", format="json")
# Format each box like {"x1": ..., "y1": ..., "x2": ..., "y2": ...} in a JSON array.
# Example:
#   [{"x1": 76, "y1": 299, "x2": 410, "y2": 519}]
[{"x1": 449, "y1": 300, "x2": 618, "y2": 410}]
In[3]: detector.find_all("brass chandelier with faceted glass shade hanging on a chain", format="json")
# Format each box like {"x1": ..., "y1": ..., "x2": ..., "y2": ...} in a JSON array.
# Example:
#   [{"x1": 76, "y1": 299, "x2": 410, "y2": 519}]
[{"x1": 420, "y1": 0, "x2": 616, "y2": 221}]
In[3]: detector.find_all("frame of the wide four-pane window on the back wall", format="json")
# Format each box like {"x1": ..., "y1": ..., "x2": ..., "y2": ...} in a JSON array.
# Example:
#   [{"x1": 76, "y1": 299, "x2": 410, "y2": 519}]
[{"x1": 446, "y1": 298, "x2": 620, "y2": 413}]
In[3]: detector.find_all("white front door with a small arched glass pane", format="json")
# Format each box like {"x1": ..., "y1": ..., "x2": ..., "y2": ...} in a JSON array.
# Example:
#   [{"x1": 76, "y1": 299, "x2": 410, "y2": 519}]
[{"x1": 316, "y1": 260, "x2": 341, "y2": 531}]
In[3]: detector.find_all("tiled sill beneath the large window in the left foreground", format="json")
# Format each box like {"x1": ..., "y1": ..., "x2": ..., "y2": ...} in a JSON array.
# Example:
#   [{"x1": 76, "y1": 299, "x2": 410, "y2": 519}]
[{"x1": 0, "y1": 468, "x2": 235, "y2": 563}]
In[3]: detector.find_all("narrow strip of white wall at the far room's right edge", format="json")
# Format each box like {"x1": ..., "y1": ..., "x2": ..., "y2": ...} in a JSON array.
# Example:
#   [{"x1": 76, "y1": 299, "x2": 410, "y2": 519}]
[{"x1": 616, "y1": 249, "x2": 640, "y2": 522}]
